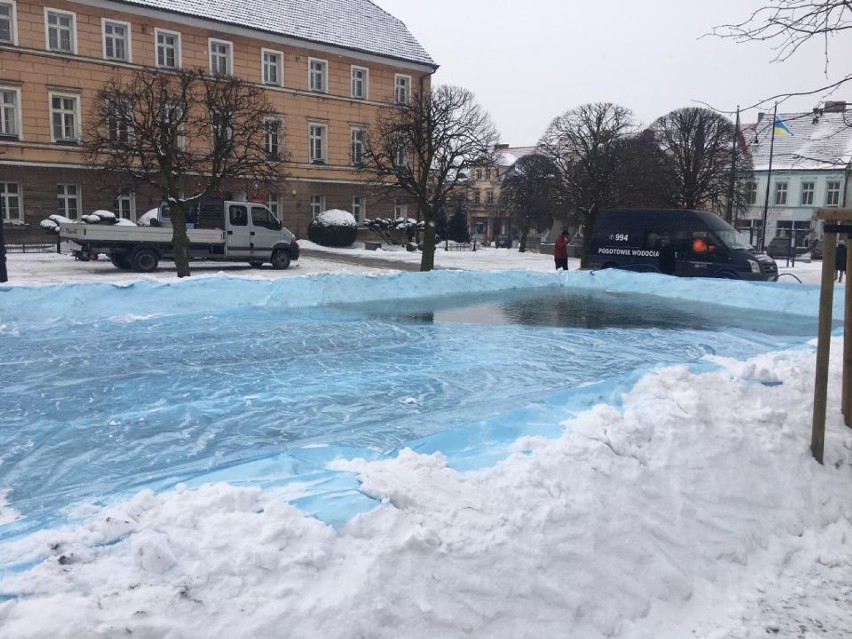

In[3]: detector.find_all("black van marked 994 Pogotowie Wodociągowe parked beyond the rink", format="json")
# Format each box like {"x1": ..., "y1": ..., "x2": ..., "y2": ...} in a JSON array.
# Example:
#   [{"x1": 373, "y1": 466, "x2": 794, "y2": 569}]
[{"x1": 588, "y1": 209, "x2": 778, "y2": 280}]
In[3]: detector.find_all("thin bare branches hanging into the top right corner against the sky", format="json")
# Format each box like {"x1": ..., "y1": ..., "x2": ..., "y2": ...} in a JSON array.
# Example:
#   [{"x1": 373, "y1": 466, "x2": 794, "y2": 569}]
[{"x1": 712, "y1": 0, "x2": 852, "y2": 106}]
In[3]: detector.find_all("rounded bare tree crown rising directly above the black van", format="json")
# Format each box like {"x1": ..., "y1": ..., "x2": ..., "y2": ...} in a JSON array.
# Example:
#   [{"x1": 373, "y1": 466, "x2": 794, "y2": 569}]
[{"x1": 651, "y1": 107, "x2": 752, "y2": 213}]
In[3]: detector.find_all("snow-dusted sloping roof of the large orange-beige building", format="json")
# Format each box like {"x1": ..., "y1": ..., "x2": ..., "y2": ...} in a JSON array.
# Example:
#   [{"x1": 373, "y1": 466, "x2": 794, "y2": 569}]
[{"x1": 111, "y1": 0, "x2": 438, "y2": 68}]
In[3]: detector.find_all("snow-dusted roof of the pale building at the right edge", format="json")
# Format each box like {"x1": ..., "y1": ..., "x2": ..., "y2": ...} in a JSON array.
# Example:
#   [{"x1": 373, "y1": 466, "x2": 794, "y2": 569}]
[{"x1": 743, "y1": 111, "x2": 852, "y2": 171}]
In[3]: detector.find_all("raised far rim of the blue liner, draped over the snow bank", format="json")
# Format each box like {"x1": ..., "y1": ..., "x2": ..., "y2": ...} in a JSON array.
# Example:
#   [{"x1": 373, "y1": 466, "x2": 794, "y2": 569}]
[{"x1": 0, "y1": 269, "x2": 844, "y2": 332}]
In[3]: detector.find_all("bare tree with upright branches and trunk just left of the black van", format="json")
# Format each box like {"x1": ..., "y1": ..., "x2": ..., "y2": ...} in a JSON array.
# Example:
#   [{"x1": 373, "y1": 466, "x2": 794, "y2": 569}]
[{"x1": 539, "y1": 102, "x2": 635, "y2": 266}]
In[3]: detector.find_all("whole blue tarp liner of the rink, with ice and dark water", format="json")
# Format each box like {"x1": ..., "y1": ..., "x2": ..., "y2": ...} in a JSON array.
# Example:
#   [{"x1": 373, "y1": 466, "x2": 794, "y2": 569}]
[{"x1": 0, "y1": 271, "x2": 842, "y2": 540}]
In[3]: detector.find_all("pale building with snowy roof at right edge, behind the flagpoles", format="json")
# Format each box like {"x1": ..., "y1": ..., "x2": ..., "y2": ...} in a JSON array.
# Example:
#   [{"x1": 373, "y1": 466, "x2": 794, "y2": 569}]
[{"x1": 736, "y1": 102, "x2": 852, "y2": 250}]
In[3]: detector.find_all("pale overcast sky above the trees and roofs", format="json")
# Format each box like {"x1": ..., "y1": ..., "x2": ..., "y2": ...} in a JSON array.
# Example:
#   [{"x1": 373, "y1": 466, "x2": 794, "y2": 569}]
[{"x1": 373, "y1": 0, "x2": 852, "y2": 146}]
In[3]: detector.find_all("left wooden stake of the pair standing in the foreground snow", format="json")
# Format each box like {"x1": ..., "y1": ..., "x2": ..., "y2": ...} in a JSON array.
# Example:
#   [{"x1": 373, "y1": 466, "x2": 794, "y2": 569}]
[{"x1": 811, "y1": 232, "x2": 837, "y2": 464}]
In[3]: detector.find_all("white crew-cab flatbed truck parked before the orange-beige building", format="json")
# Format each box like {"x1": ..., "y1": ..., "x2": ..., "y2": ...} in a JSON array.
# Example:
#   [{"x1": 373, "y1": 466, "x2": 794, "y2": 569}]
[{"x1": 59, "y1": 200, "x2": 299, "y2": 273}]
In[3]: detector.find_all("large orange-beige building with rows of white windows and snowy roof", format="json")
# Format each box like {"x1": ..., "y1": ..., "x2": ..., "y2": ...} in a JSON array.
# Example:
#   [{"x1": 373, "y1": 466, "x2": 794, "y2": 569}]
[{"x1": 0, "y1": 0, "x2": 437, "y2": 242}]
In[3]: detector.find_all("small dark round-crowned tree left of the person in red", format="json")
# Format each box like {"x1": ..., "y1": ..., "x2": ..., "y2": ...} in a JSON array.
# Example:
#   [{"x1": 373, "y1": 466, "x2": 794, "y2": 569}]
[{"x1": 500, "y1": 153, "x2": 562, "y2": 253}]
